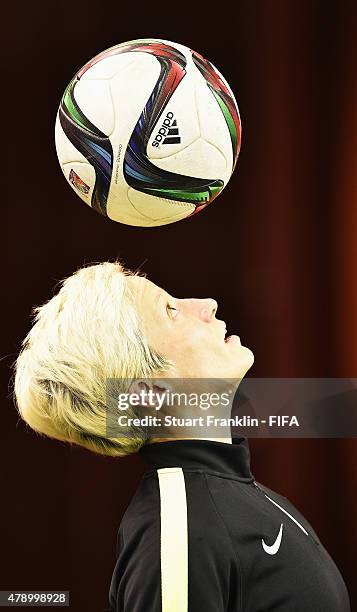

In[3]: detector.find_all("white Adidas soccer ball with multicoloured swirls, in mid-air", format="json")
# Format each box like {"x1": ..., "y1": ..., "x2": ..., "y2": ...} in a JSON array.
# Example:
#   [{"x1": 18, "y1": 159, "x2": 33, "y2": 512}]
[{"x1": 55, "y1": 39, "x2": 241, "y2": 227}]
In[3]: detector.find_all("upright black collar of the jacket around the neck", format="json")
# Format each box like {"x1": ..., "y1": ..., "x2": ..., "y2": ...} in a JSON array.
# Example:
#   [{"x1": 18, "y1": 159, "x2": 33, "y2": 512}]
[{"x1": 139, "y1": 438, "x2": 254, "y2": 482}]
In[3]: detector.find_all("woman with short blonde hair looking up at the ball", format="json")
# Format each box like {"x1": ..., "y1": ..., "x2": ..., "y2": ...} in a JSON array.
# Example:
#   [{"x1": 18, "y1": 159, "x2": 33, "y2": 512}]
[{"x1": 15, "y1": 263, "x2": 350, "y2": 612}]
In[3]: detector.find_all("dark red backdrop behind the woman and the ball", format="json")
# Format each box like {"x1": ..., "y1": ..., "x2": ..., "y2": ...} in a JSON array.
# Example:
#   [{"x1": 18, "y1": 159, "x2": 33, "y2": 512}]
[{"x1": 0, "y1": 0, "x2": 357, "y2": 612}]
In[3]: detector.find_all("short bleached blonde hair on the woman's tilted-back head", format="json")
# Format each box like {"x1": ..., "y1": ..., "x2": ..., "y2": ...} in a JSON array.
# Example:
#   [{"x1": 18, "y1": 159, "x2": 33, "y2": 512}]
[{"x1": 14, "y1": 261, "x2": 171, "y2": 456}]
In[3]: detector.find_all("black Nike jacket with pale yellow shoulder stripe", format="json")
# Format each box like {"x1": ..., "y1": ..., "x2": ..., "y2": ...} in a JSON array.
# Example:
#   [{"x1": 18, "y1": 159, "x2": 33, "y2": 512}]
[{"x1": 109, "y1": 438, "x2": 350, "y2": 612}]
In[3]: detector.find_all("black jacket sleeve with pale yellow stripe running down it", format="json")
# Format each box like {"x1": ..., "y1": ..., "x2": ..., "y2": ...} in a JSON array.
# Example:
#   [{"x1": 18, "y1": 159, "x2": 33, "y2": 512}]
[{"x1": 111, "y1": 467, "x2": 239, "y2": 612}]
